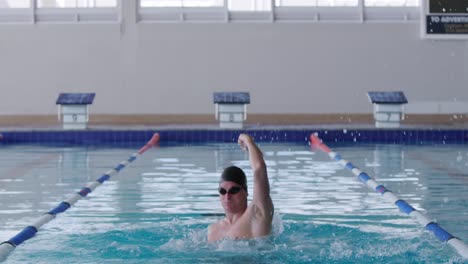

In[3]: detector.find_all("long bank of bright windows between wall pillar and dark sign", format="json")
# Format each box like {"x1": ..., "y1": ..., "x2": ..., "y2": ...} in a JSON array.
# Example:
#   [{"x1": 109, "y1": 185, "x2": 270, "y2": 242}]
[{"x1": 138, "y1": 0, "x2": 420, "y2": 22}]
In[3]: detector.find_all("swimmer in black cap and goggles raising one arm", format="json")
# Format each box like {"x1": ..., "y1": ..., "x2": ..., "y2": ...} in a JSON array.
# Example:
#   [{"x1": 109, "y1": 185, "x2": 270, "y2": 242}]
[{"x1": 208, "y1": 134, "x2": 274, "y2": 242}]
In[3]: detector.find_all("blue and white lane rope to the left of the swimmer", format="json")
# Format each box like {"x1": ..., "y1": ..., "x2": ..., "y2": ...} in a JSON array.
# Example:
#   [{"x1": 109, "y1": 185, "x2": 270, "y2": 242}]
[{"x1": 0, "y1": 133, "x2": 159, "y2": 262}]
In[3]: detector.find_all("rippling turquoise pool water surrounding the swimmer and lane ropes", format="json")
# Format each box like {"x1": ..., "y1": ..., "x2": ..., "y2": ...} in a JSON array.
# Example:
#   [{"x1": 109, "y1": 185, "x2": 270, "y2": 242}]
[{"x1": 0, "y1": 143, "x2": 468, "y2": 263}]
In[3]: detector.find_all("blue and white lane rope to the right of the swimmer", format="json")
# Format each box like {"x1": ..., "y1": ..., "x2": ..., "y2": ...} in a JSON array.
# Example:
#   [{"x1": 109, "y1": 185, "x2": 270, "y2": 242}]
[{"x1": 310, "y1": 134, "x2": 468, "y2": 259}]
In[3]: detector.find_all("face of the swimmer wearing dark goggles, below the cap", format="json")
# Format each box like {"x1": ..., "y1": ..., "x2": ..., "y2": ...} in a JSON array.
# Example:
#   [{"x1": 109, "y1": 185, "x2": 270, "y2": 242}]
[{"x1": 219, "y1": 181, "x2": 247, "y2": 213}]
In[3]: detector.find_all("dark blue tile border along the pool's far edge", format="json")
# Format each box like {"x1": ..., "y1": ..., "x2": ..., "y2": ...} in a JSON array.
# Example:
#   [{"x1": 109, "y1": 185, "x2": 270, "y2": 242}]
[{"x1": 0, "y1": 129, "x2": 468, "y2": 145}]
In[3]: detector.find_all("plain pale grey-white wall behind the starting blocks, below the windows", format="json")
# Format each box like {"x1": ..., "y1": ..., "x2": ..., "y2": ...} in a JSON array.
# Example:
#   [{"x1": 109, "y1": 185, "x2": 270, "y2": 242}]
[{"x1": 0, "y1": 9, "x2": 468, "y2": 115}]
